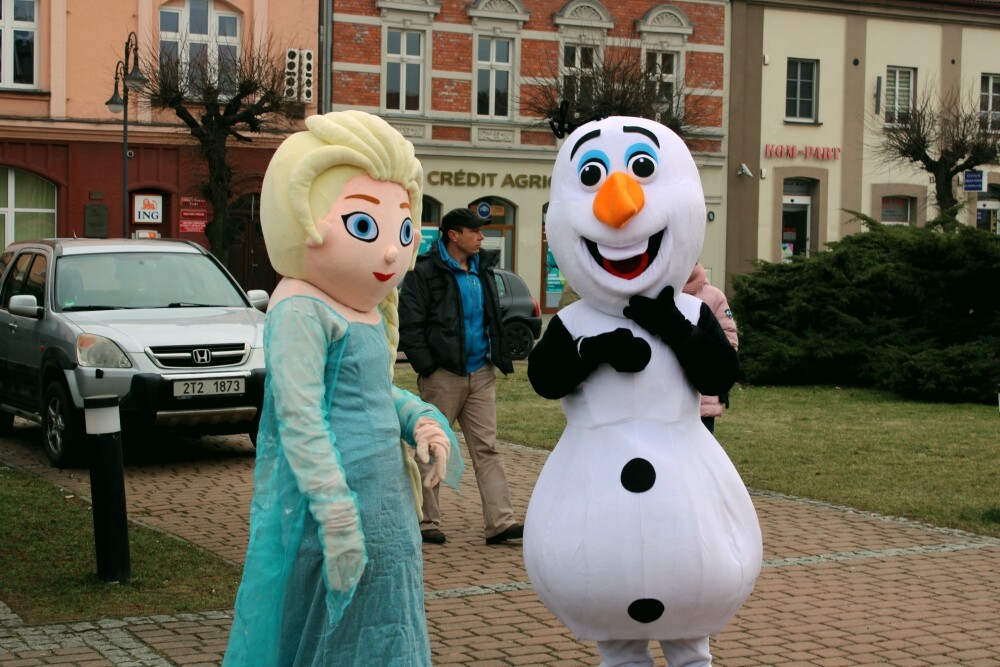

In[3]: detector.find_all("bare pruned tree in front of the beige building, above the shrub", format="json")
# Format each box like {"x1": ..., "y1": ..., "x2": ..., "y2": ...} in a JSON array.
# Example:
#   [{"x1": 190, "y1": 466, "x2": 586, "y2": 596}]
[{"x1": 875, "y1": 86, "x2": 1000, "y2": 228}]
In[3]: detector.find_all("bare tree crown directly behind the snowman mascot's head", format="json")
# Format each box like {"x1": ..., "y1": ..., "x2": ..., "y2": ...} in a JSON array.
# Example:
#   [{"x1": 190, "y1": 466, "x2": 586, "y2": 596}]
[{"x1": 521, "y1": 41, "x2": 712, "y2": 145}]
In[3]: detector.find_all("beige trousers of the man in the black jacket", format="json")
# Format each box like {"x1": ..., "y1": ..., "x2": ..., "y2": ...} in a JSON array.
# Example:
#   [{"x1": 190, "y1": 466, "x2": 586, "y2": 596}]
[{"x1": 417, "y1": 363, "x2": 515, "y2": 537}]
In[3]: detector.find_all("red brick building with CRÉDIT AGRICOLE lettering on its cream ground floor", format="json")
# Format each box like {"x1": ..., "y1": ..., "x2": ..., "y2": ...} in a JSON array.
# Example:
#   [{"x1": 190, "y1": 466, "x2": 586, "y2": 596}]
[{"x1": 332, "y1": 0, "x2": 729, "y2": 312}]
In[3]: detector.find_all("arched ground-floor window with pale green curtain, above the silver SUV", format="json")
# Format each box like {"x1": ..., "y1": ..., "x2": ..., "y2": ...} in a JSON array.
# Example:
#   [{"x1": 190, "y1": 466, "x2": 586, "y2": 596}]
[{"x1": 0, "y1": 167, "x2": 56, "y2": 247}]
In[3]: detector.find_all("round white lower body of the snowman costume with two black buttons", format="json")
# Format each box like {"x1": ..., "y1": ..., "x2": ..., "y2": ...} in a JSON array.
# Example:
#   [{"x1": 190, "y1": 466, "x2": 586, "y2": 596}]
[{"x1": 524, "y1": 412, "x2": 762, "y2": 640}]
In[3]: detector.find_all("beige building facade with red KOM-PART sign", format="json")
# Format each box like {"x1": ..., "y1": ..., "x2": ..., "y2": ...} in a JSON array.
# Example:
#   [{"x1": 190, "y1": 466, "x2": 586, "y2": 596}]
[{"x1": 726, "y1": 0, "x2": 1000, "y2": 290}]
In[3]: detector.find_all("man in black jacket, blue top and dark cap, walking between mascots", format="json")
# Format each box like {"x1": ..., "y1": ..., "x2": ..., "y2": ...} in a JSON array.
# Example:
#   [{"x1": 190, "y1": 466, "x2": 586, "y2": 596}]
[{"x1": 399, "y1": 208, "x2": 524, "y2": 544}]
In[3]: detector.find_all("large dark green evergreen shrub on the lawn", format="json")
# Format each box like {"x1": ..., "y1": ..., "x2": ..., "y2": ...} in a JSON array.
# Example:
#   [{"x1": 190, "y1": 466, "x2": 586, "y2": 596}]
[{"x1": 730, "y1": 218, "x2": 1000, "y2": 403}]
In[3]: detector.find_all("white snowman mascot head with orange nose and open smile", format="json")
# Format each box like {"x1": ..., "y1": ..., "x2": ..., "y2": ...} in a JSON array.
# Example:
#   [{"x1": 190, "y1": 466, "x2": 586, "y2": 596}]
[{"x1": 545, "y1": 116, "x2": 705, "y2": 317}]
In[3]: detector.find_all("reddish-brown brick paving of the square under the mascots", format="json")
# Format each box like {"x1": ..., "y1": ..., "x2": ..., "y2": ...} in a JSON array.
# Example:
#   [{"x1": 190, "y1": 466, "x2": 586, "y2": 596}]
[{"x1": 0, "y1": 421, "x2": 1000, "y2": 667}]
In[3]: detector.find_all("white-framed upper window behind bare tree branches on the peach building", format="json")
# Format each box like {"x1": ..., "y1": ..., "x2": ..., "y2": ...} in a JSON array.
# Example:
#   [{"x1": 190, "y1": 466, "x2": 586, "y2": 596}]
[{"x1": 160, "y1": 0, "x2": 240, "y2": 97}]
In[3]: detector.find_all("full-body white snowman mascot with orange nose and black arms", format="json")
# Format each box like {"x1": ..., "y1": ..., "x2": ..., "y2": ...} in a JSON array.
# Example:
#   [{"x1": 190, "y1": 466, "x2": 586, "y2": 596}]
[{"x1": 524, "y1": 116, "x2": 762, "y2": 667}]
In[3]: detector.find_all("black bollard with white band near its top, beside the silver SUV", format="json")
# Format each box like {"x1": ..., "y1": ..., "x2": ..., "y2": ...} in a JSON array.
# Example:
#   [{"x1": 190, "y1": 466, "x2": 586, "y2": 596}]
[{"x1": 83, "y1": 396, "x2": 132, "y2": 584}]
